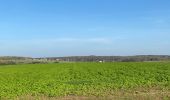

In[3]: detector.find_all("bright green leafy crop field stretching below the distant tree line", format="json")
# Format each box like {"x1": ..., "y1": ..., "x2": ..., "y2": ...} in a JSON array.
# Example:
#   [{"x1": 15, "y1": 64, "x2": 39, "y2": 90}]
[{"x1": 0, "y1": 62, "x2": 170, "y2": 99}]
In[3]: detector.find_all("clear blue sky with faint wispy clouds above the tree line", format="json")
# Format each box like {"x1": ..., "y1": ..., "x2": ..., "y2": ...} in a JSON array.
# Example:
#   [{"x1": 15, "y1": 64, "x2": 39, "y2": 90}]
[{"x1": 0, "y1": 0, "x2": 170, "y2": 57}]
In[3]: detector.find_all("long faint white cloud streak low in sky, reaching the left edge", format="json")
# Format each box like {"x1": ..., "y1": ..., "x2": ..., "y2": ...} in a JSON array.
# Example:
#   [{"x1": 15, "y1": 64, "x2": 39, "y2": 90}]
[{"x1": 0, "y1": 37, "x2": 126, "y2": 47}]
